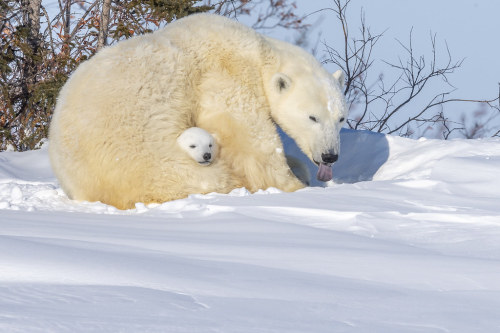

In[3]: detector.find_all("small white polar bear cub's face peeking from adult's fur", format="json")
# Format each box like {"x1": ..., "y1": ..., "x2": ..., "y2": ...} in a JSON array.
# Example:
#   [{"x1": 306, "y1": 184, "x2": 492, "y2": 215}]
[{"x1": 177, "y1": 127, "x2": 217, "y2": 166}]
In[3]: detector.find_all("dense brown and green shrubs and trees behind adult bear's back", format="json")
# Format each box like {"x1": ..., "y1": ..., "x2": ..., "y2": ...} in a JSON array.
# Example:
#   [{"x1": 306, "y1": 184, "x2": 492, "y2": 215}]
[{"x1": 0, "y1": 0, "x2": 306, "y2": 151}]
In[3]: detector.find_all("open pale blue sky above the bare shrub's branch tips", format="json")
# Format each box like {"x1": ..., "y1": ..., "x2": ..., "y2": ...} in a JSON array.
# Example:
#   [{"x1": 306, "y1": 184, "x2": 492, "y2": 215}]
[{"x1": 296, "y1": 0, "x2": 500, "y2": 104}]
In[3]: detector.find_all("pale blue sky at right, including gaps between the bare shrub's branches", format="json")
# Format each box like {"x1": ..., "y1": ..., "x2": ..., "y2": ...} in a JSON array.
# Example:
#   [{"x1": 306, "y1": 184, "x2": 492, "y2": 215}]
[{"x1": 290, "y1": 0, "x2": 500, "y2": 138}]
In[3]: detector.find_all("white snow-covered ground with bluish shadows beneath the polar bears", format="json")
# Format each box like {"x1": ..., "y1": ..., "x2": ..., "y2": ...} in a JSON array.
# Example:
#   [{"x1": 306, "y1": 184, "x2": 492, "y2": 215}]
[{"x1": 0, "y1": 131, "x2": 500, "y2": 333}]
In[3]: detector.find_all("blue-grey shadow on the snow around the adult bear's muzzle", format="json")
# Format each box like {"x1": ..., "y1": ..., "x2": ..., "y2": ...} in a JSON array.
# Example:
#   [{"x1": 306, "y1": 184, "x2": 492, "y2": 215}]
[{"x1": 277, "y1": 127, "x2": 389, "y2": 186}]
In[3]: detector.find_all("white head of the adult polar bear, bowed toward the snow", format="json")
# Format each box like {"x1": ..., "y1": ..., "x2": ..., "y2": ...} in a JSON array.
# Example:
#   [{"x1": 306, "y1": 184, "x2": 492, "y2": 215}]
[{"x1": 264, "y1": 40, "x2": 348, "y2": 181}]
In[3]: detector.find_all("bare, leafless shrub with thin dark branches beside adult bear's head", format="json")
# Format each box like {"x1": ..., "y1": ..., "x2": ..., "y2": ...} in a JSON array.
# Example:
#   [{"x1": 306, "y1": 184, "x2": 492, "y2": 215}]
[{"x1": 318, "y1": 0, "x2": 500, "y2": 139}]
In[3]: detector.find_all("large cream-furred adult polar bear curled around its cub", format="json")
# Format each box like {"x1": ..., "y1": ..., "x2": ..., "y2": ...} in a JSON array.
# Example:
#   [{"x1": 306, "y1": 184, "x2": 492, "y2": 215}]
[{"x1": 49, "y1": 14, "x2": 347, "y2": 209}]
